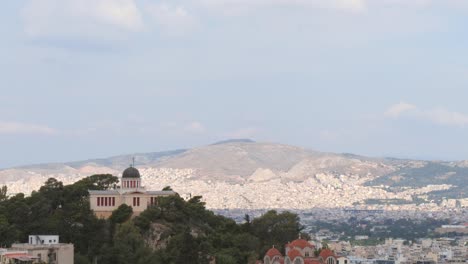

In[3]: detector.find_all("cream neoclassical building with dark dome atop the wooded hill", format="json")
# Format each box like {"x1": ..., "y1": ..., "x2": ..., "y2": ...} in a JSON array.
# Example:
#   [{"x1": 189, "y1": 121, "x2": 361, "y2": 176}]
[{"x1": 89, "y1": 166, "x2": 176, "y2": 218}]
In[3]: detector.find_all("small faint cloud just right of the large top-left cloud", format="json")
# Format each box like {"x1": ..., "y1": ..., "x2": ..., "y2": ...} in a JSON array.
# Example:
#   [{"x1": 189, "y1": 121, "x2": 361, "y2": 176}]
[{"x1": 145, "y1": 3, "x2": 199, "y2": 36}]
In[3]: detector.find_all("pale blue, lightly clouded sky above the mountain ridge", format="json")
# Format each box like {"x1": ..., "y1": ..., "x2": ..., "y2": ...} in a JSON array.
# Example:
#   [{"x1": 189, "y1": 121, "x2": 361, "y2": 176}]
[{"x1": 0, "y1": 0, "x2": 468, "y2": 168}]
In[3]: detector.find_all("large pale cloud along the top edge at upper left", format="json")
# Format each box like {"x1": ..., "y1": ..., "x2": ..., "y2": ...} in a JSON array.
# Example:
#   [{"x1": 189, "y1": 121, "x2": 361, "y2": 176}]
[{"x1": 21, "y1": 0, "x2": 144, "y2": 37}]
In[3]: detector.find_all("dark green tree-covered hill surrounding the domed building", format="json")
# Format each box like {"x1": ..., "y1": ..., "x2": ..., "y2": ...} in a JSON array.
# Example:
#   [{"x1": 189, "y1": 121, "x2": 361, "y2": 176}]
[{"x1": 0, "y1": 175, "x2": 302, "y2": 264}]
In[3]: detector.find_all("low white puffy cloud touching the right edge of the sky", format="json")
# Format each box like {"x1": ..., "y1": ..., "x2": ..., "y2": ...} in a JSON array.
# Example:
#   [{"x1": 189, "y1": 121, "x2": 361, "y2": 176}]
[{"x1": 384, "y1": 102, "x2": 468, "y2": 127}]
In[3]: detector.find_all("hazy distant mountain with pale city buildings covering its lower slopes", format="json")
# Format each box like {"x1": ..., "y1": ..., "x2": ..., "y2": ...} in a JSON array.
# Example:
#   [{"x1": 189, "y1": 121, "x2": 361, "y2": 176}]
[{"x1": 0, "y1": 139, "x2": 468, "y2": 208}]
